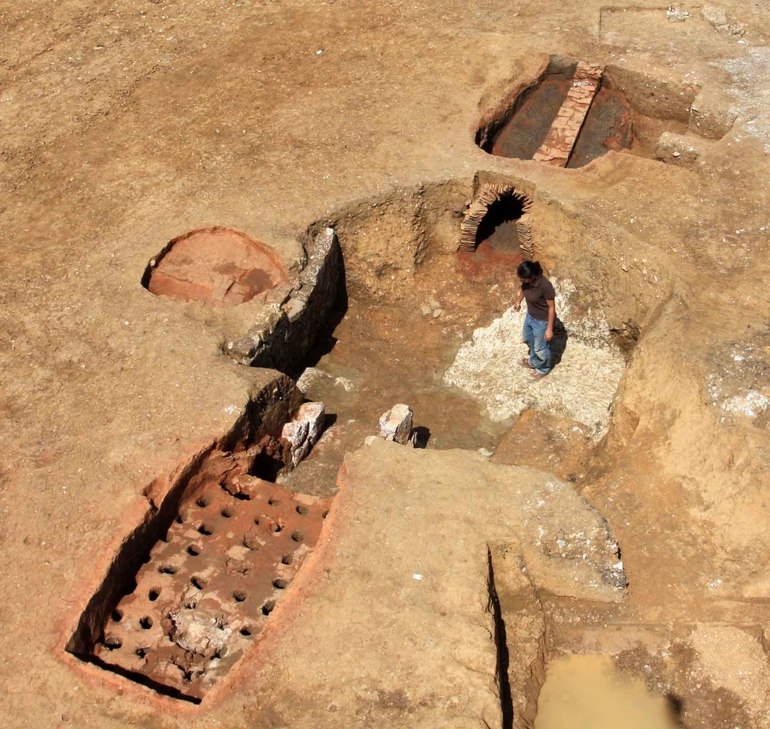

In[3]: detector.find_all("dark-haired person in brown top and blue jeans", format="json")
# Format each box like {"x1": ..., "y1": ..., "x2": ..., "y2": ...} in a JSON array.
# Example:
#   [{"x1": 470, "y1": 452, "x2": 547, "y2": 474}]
[{"x1": 513, "y1": 261, "x2": 556, "y2": 382}]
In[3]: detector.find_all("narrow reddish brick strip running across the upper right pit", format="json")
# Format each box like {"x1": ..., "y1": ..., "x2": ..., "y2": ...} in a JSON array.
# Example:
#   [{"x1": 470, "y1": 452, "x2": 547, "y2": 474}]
[{"x1": 532, "y1": 61, "x2": 604, "y2": 167}]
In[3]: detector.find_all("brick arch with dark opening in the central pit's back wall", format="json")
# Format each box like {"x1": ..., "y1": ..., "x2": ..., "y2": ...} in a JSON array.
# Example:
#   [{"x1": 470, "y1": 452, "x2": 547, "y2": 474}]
[{"x1": 457, "y1": 182, "x2": 535, "y2": 260}]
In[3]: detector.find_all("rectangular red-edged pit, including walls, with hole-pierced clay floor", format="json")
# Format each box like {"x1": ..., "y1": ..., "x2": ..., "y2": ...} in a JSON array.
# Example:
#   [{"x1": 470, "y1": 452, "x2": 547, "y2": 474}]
[{"x1": 66, "y1": 388, "x2": 330, "y2": 703}]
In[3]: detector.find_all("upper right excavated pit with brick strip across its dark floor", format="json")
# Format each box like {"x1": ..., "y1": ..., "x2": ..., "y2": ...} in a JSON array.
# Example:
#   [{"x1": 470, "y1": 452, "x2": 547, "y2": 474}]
[{"x1": 476, "y1": 56, "x2": 721, "y2": 168}]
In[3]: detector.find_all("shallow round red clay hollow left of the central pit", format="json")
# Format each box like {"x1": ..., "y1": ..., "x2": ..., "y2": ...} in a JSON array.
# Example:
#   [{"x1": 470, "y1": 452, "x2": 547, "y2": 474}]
[{"x1": 144, "y1": 227, "x2": 287, "y2": 307}]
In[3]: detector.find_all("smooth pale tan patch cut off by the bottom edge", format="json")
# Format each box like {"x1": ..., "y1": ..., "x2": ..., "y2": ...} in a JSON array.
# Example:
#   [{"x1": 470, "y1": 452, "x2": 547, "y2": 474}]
[{"x1": 535, "y1": 655, "x2": 679, "y2": 729}]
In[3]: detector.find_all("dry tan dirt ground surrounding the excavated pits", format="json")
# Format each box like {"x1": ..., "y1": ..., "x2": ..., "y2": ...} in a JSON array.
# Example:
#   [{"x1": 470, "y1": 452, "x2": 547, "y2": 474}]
[{"x1": 0, "y1": 0, "x2": 770, "y2": 729}]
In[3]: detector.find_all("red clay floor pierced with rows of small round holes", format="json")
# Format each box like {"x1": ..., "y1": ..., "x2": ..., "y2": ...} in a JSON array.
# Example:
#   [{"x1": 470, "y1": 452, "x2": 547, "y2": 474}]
[{"x1": 94, "y1": 478, "x2": 326, "y2": 698}]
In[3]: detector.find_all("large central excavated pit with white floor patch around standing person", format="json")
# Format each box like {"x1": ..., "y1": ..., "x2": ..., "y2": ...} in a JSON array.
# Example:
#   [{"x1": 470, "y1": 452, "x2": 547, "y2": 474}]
[{"x1": 272, "y1": 173, "x2": 664, "y2": 494}]
